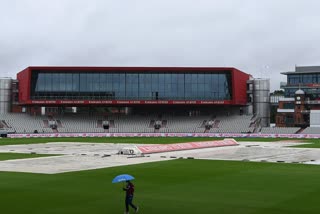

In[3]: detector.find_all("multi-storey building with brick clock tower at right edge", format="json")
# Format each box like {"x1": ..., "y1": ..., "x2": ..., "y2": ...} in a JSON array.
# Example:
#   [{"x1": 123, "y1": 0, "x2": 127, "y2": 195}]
[{"x1": 276, "y1": 66, "x2": 320, "y2": 128}]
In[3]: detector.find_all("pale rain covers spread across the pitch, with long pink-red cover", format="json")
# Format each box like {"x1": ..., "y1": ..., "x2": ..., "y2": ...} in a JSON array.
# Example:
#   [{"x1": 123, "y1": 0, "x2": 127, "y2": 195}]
[{"x1": 0, "y1": 138, "x2": 320, "y2": 174}]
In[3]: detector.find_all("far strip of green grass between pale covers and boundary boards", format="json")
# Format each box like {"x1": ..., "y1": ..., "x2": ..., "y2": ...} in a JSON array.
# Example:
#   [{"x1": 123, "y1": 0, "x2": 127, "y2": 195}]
[{"x1": 0, "y1": 137, "x2": 320, "y2": 148}]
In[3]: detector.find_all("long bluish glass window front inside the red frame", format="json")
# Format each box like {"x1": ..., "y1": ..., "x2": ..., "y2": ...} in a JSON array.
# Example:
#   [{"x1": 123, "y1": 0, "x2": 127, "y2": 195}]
[{"x1": 31, "y1": 71, "x2": 232, "y2": 100}]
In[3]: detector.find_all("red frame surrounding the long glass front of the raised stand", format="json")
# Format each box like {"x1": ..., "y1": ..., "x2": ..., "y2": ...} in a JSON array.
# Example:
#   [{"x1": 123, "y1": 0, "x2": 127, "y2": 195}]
[{"x1": 17, "y1": 67, "x2": 250, "y2": 106}]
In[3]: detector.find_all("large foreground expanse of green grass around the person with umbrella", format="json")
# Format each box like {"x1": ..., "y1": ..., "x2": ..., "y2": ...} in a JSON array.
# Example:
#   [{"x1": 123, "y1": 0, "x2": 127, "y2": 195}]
[{"x1": 0, "y1": 159, "x2": 320, "y2": 214}]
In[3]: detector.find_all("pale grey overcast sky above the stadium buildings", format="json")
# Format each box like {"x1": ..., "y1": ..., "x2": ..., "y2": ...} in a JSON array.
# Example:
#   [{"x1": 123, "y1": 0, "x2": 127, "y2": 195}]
[{"x1": 0, "y1": 0, "x2": 320, "y2": 90}]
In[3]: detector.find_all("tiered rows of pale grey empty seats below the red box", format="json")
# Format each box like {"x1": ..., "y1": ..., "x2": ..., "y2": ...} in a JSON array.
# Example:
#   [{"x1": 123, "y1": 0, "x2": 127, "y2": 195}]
[{"x1": 0, "y1": 113, "x2": 312, "y2": 134}]
